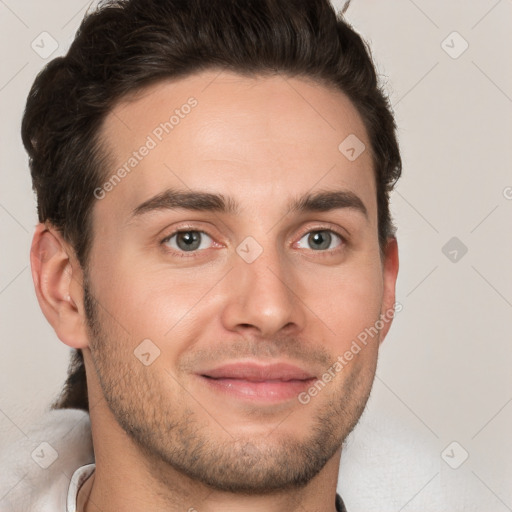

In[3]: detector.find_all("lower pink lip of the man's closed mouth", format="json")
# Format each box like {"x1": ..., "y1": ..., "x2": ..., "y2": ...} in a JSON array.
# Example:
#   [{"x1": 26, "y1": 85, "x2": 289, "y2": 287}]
[{"x1": 201, "y1": 376, "x2": 315, "y2": 402}]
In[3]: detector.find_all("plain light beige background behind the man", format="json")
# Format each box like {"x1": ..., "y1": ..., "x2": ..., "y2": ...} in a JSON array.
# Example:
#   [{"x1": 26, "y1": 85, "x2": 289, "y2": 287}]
[{"x1": 0, "y1": 0, "x2": 512, "y2": 512}]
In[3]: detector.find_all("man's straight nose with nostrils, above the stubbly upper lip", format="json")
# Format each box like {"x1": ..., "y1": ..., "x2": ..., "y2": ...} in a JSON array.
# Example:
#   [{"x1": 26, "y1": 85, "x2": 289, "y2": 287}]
[{"x1": 221, "y1": 241, "x2": 305, "y2": 337}]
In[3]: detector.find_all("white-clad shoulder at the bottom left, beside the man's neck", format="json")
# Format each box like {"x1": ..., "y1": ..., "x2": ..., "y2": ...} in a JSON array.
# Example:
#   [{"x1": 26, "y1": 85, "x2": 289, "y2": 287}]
[{"x1": 0, "y1": 409, "x2": 94, "y2": 512}]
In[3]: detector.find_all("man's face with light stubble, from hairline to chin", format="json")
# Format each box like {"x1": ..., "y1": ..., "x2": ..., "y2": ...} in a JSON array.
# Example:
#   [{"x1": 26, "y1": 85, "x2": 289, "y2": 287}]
[{"x1": 82, "y1": 71, "x2": 396, "y2": 492}]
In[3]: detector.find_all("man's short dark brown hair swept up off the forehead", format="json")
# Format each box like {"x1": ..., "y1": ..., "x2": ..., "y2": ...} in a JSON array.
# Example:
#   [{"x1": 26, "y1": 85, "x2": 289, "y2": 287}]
[{"x1": 22, "y1": 0, "x2": 401, "y2": 409}]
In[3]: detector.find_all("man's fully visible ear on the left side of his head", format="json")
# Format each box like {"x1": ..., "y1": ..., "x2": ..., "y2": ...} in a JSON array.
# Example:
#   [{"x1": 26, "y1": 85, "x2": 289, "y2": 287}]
[{"x1": 30, "y1": 224, "x2": 89, "y2": 348}]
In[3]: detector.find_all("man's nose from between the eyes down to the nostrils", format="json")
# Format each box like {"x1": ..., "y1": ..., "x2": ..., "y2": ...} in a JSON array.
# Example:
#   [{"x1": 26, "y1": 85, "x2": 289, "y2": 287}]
[{"x1": 223, "y1": 237, "x2": 302, "y2": 336}]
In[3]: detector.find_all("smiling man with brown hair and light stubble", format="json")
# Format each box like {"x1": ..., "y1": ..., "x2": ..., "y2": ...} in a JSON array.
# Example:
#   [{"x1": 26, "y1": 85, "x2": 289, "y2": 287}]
[{"x1": 4, "y1": 0, "x2": 401, "y2": 512}]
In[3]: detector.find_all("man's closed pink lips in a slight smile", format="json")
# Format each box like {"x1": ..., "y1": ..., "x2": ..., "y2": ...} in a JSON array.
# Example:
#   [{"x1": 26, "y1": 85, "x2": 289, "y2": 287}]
[{"x1": 198, "y1": 363, "x2": 316, "y2": 402}]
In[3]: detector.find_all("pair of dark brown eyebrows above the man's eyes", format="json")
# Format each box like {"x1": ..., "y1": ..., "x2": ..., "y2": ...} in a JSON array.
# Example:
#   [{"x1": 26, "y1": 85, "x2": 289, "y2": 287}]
[{"x1": 130, "y1": 188, "x2": 368, "y2": 219}]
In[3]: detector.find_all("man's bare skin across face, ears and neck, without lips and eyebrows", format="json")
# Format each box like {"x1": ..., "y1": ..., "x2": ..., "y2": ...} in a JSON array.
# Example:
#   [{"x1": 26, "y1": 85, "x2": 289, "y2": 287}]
[{"x1": 32, "y1": 71, "x2": 398, "y2": 512}]
